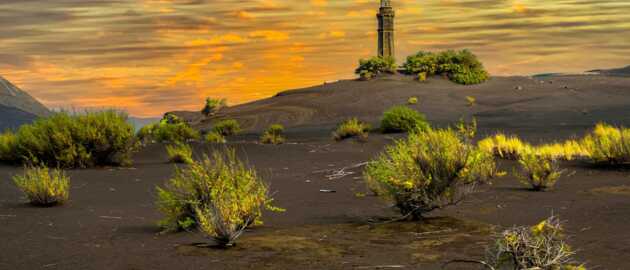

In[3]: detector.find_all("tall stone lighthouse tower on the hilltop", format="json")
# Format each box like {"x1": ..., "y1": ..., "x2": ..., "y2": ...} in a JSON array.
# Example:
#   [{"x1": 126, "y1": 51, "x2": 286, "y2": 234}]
[{"x1": 376, "y1": 0, "x2": 395, "y2": 57}]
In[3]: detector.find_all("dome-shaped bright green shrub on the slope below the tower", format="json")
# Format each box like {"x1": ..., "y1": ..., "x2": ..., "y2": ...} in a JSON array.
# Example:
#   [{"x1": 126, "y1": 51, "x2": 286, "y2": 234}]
[{"x1": 381, "y1": 106, "x2": 430, "y2": 133}]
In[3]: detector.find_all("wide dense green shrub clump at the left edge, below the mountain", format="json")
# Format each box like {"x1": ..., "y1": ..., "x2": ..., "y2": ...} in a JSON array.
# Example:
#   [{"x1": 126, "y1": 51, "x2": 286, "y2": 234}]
[{"x1": 0, "y1": 110, "x2": 136, "y2": 168}]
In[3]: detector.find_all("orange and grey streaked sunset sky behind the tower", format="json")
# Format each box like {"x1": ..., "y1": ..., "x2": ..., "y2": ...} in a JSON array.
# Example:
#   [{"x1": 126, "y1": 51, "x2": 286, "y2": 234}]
[{"x1": 0, "y1": 0, "x2": 630, "y2": 117}]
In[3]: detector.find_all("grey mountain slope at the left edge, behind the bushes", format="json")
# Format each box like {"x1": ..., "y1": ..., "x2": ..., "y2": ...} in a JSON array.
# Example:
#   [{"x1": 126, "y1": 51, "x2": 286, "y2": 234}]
[{"x1": 0, "y1": 77, "x2": 51, "y2": 131}]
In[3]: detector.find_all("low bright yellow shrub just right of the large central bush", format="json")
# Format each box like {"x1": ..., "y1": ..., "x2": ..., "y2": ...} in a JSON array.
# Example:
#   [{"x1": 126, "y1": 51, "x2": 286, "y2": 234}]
[{"x1": 477, "y1": 133, "x2": 531, "y2": 160}]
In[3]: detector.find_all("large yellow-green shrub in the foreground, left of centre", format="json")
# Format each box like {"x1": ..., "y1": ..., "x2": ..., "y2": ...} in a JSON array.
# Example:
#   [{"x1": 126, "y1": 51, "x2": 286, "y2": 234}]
[{"x1": 157, "y1": 150, "x2": 279, "y2": 246}]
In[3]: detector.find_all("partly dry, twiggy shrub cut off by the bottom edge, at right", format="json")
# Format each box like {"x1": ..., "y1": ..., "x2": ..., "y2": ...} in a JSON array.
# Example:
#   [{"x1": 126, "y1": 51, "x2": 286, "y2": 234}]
[{"x1": 488, "y1": 217, "x2": 586, "y2": 270}]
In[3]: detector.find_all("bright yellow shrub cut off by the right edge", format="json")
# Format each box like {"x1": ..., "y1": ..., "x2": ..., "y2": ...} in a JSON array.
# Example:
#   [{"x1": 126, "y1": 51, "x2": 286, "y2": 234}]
[{"x1": 582, "y1": 123, "x2": 630, "y2": 165}]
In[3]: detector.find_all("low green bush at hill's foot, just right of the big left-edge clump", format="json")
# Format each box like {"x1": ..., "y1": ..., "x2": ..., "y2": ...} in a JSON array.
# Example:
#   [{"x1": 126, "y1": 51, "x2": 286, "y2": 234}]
[{"x1": 137, "y1": 114, "x2": 200, "y2": 143}]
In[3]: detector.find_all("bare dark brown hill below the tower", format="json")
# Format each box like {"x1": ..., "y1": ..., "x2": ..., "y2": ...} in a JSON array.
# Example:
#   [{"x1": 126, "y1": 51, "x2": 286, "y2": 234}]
[{"x1": 174, "y1": 75, "x2": 630, "y2": 138}]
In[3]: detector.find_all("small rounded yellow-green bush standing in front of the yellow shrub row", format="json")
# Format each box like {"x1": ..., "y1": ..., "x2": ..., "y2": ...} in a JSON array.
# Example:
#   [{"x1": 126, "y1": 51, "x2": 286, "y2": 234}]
[{"x1": 517, "y1": 151, "x2": 562, "y2": 191}]
